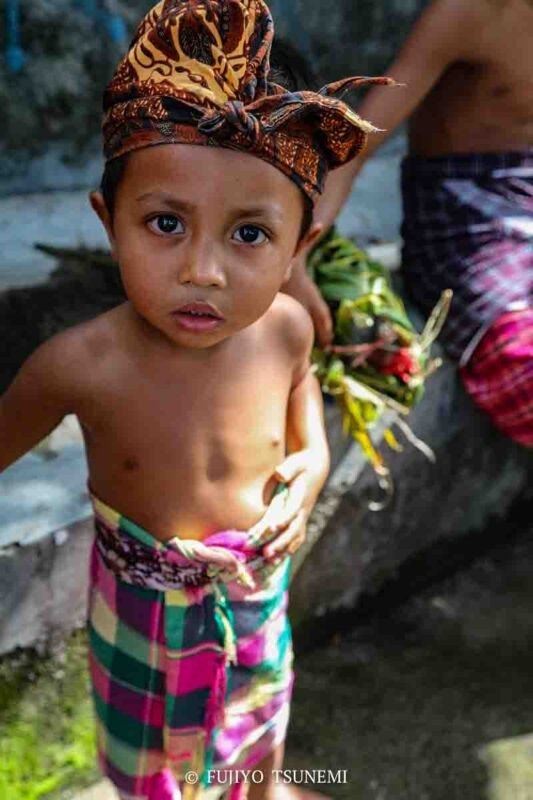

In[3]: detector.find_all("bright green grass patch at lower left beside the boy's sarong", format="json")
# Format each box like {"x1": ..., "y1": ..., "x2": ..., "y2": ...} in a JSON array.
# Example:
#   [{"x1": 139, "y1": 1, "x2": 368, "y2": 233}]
[{"x1": 0, "y1": 631, "x2": 97, "y2": 800}]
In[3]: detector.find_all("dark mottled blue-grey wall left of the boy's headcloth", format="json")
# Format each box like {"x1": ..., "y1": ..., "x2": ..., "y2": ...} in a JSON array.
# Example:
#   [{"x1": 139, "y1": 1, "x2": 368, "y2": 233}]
[{"x1": 0, "y1": 0, "x2": 148, "y2": 191}]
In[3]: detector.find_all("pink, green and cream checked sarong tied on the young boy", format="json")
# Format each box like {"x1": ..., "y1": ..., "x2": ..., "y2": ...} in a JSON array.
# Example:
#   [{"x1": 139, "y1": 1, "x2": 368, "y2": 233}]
[{"x1": 89, "y1": 496, "x2": 293, "y2": 800}]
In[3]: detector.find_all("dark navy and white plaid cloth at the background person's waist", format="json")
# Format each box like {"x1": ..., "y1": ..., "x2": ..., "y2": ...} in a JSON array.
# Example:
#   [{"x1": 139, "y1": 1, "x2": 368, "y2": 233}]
[{"x1": 402, "y1": 150, "x2": 533, "y2": 359}]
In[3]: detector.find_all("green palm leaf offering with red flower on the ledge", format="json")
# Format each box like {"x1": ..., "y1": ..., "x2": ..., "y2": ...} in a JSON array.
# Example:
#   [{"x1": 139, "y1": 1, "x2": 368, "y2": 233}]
[{"x1": 308, "y1": 229, "x2": 452, "y2": 510}]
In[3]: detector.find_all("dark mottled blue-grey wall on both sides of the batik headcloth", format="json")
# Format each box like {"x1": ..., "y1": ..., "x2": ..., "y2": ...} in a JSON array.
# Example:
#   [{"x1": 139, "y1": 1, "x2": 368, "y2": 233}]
[{"x1": 0, "y1": 0, "x2": 426, "y2": 194}]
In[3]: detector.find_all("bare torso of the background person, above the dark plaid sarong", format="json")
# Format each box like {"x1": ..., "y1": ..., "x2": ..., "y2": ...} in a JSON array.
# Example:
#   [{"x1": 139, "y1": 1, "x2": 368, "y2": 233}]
[{"x1": 409, "y1": 0, "x2": 533, "y2": 157}]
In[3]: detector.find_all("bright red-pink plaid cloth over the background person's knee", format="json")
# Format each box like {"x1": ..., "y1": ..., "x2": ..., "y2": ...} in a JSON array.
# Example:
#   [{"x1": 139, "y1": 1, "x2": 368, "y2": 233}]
[{"x1": 461, "y1": 309, "x2": 533, "y2": 447}]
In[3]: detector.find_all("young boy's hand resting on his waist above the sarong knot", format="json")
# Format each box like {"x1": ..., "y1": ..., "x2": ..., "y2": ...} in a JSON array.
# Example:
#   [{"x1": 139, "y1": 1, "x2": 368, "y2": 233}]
[{"x1": 250, "y1": 450, "x2": 327, "y2": 561}]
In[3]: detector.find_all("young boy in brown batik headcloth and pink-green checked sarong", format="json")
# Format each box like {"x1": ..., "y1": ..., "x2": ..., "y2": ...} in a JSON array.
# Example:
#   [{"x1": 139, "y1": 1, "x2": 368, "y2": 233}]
[{"x1": 0, "y1": 0, "x2": 384, "y2": 800}]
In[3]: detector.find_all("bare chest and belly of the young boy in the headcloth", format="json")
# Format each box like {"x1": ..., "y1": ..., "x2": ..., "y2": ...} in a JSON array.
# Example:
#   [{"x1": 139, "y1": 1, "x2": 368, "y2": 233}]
[{"x1": 73, "y1": 304, "x2": 294, "y2": 540}]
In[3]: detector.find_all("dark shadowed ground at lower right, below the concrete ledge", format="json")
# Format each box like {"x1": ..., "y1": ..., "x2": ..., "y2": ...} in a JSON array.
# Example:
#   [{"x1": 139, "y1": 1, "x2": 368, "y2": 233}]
[{"x1": 287, "y1": 520, "x2": 533, "y2": 800}]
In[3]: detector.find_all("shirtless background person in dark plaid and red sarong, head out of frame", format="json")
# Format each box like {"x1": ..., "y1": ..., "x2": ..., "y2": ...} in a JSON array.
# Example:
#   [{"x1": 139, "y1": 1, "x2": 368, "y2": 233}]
[{"x1": 290, "y1": 0, "x2": 533, "y2": 447}]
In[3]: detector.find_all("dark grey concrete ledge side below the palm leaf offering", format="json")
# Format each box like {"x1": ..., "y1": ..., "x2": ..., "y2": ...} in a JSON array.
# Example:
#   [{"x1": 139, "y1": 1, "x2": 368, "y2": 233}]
[{"x1": 291, "y1": 363, "x2": 533, "y2": 630}]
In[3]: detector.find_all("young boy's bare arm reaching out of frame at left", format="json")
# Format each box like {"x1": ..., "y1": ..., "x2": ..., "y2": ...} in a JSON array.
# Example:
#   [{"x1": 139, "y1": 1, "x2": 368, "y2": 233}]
[{"x1": 0, "y1": 335, "x2": 75, "y2": 472}]
